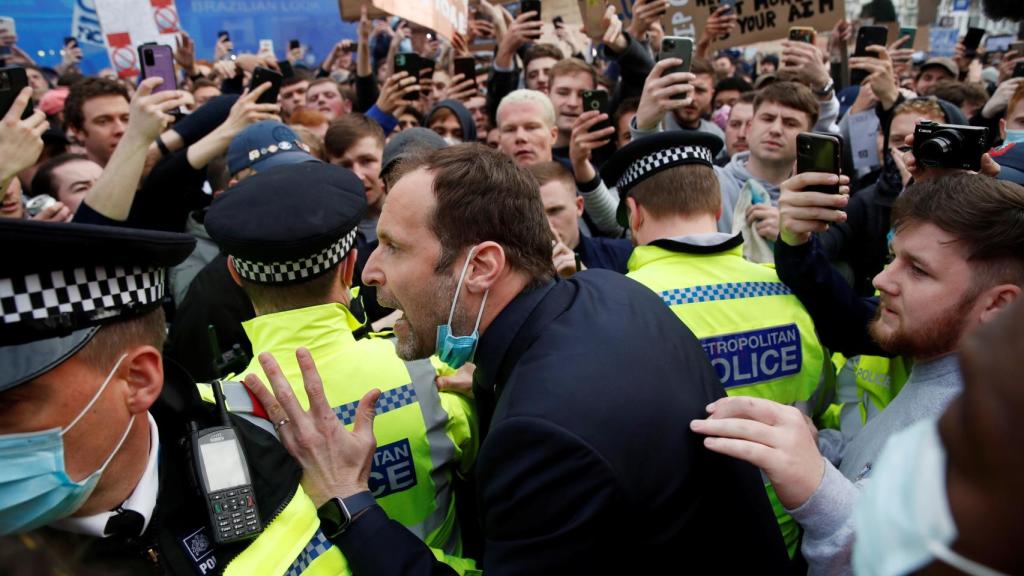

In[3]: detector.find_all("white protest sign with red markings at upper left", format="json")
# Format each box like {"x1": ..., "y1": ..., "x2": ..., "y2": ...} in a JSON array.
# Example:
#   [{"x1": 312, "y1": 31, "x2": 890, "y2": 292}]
[{"x1": 95, "y1": 0, "x2": 181, "y2": 78}]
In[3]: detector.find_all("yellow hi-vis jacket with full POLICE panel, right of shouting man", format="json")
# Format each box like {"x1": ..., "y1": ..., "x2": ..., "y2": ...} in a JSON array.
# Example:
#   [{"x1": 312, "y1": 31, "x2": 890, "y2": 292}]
[{"x1": 627, "y1": 235, "x2": 831, "y2": 556}]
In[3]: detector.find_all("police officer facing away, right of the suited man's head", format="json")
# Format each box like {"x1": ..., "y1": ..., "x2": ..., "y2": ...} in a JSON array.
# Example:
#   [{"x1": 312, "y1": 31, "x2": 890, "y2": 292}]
[{"x1": 601, "y1": 130, "x2": 830, "y2": 556}]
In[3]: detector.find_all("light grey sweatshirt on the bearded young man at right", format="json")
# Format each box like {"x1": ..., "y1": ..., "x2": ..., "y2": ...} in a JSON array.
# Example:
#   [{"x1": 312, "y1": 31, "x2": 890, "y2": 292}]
[{"x1": 788, "y1": 354, "x2": 964, "y2": 575}]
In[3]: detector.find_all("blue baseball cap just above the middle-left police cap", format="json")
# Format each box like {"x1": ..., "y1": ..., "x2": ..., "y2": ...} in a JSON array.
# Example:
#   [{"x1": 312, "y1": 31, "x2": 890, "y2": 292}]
[{"x1": 227, "y1": 120, "x2": 319, "y2": 175}]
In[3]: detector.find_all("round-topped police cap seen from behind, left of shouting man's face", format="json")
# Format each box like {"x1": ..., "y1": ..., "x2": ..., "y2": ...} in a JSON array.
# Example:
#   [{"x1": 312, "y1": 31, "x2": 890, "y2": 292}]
[{"x1": 204, "y1": 162, "x2": 367, "y2": 285}]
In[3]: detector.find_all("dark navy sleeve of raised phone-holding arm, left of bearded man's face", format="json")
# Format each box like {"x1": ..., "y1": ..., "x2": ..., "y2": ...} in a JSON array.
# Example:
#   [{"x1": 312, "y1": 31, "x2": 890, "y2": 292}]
[{"x1": 775, "y1": 238, "x2": 891, "y2": 358}]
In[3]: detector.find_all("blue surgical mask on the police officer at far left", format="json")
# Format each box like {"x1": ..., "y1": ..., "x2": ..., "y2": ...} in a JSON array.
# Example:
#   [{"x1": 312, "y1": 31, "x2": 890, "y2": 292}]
[{"x1": 0, "y1": 356, "x2": 135, "y2": 534}]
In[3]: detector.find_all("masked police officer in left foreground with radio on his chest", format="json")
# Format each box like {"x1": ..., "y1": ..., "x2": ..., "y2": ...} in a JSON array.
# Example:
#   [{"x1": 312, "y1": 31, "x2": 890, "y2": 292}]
[{"x1": 0, "y1": 220, "x2": 341, "y2": 574}]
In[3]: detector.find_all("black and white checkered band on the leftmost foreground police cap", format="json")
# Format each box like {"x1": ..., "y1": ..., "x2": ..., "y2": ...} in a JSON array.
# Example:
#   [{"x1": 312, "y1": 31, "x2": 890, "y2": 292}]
[{"x1": 0, "y1": 266, "x2": 166, "y2": 333}]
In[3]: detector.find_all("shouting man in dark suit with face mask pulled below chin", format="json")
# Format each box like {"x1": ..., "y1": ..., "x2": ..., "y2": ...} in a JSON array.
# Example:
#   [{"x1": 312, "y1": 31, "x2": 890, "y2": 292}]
[{"x1": 246, "y1": 145, "x2": 788, "y2": 575}]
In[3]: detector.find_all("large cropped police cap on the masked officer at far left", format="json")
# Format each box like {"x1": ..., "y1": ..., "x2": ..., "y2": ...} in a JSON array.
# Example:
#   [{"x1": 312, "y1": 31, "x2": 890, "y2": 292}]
[{"x1": 0, "y1": 218, "x2": 196, "y2": 390}]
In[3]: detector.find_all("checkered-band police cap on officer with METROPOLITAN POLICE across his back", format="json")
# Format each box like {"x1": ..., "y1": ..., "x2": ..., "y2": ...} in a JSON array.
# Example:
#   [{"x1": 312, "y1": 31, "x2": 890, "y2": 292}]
[{"x1": 601, "y1": 130, "x2": 724, "y2": 228}]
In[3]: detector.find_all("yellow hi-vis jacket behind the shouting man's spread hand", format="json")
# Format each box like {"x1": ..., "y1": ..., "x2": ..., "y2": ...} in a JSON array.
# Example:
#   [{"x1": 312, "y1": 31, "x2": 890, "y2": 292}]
[{"x1": 200, "y1": 303, "x2": 478, "y2": 574}]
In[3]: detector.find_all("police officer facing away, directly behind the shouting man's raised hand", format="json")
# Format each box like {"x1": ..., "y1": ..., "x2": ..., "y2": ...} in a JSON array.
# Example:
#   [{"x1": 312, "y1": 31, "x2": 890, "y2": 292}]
[{"x1": 206, "y1": 163, "x2": 476, "y2": 570}]
